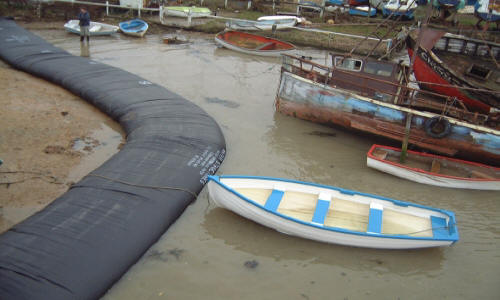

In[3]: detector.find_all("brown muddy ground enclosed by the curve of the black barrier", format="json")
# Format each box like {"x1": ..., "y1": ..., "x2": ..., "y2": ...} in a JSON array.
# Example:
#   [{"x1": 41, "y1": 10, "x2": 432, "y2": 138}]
[{"x1": 0, "y1": 61, "x2": 124, "y2": 232}]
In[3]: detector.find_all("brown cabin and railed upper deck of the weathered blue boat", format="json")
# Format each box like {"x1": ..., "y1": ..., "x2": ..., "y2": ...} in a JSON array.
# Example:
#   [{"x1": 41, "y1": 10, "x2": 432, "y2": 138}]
[{"x1": 281, "y1": 53, "x2": 494, "y2": 129}]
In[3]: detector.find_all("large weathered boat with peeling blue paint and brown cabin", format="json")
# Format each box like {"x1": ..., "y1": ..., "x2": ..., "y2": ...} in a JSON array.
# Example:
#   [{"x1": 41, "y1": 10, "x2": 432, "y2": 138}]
[{"x1": 275, "y1": 53, "x2": 500, "y2": 166}]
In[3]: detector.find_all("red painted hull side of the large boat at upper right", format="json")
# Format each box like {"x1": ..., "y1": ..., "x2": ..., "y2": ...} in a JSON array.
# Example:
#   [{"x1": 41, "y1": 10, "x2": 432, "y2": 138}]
[{"x1": 408, "y1": 49, "x2": 490, "y2": 113}]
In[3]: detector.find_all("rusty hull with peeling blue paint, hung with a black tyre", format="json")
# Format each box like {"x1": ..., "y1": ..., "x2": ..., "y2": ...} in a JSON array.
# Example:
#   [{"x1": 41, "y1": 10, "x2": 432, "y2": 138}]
[{"x1": 276, "y1": 69, "x2": 500, "y2": 165}]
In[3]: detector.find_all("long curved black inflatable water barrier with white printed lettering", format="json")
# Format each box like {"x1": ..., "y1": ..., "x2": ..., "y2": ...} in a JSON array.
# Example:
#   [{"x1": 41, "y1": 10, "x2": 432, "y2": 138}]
[{"x1": 0, "y1": 18, "x2": 225, "y2": 299}]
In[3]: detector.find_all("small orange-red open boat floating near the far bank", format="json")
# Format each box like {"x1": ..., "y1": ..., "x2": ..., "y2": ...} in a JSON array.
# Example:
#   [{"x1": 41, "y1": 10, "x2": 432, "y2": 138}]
[{"x1": 215, "y1": 30, "x2": 295, "y2": 56}]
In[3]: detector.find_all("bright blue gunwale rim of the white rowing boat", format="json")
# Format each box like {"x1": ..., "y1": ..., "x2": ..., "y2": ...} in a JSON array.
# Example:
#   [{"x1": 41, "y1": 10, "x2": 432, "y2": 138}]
[{"x1": 208, "y1": 175, "x2": 459, "y2": 243}]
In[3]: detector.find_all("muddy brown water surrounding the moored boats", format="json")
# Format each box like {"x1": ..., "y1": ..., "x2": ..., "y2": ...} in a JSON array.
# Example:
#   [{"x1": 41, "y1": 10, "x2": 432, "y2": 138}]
[{"x1": 15, "y1": 30, "x2": 500, "y2": 300}]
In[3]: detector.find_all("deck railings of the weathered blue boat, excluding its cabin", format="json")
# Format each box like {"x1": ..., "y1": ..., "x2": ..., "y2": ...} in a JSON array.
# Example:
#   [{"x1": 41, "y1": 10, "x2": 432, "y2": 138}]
[{"x1": 282, "y1": 54, "x2": 498, "y2": 128}]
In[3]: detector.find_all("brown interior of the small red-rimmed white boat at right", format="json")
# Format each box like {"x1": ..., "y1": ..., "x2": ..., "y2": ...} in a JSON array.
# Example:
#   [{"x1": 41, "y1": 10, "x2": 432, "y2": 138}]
[{"x1": 373, "y1": 148, "x2": 500, "y2": 180}]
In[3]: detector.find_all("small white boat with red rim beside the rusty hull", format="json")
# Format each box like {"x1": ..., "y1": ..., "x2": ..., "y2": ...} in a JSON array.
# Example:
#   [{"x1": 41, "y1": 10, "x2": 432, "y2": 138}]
[{"x1": 366, "y1": 145, "x2": 500, "y2": 190}]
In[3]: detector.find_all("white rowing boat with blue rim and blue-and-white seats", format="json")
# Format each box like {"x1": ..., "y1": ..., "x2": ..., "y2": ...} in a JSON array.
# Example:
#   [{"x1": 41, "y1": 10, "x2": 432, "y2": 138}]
[{"x1": 208, "y1": 175, "x2": 459, "y2": 249}]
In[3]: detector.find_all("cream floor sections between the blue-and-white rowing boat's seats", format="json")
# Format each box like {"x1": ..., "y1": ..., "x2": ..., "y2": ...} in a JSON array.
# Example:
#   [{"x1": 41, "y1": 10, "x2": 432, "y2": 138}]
[{"x1": 235, "y1": 188, "x2": 432, "y2": 237}]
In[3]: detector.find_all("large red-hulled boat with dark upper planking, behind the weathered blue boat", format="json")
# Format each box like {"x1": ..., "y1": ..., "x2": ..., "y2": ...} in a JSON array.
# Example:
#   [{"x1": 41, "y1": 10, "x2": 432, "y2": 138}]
[{"x1": 406, "y1": 29, "x2": 500, "y2": 113}]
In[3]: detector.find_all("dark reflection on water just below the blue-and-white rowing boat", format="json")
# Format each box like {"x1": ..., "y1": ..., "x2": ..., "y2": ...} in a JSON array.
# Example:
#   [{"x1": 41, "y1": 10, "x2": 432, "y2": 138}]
[{"x1": 202, "y1": 208, "x2": 443, "y2": 275}]
